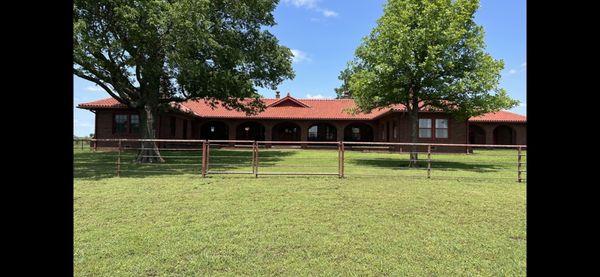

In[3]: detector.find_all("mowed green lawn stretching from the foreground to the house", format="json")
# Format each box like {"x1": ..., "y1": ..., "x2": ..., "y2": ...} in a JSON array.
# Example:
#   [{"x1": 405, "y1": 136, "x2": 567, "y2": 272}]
[{"x1": 74, "y1": 148, "x2": 526, "y2": 276}]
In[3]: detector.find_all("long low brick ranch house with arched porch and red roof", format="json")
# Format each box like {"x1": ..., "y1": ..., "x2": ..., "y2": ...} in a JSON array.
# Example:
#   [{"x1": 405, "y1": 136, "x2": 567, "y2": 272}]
[{"x1": 78, "y1": 93, "x2": 527, "y2": 149}]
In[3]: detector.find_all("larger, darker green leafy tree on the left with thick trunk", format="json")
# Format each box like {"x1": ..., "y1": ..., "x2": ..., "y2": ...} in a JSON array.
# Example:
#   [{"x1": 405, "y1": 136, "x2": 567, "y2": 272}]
[{"x1": 73, "y1": 0, "x2": 294, "y2": 162}]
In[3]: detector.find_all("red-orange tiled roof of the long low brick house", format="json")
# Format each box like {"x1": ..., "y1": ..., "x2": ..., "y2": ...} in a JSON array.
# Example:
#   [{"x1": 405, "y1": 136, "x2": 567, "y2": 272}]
[{"x1": 78, "y1": 96, "x2": 526, "y2": 122}]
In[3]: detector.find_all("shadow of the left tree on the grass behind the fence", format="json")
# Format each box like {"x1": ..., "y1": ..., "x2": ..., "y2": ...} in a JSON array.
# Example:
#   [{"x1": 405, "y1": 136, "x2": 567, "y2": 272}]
[{"x1": 73, "y1": 149, "x2": 294, "y2": 179}]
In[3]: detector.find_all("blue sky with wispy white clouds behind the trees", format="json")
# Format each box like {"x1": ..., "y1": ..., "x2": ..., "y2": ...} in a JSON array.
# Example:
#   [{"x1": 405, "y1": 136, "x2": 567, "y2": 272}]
[{"x1": 73, "y1": 0, "x2": 527, "y2": 136}]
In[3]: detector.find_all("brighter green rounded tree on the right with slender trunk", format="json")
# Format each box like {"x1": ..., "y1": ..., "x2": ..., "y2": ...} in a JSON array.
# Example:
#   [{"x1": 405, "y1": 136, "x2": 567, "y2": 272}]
[{"x1": 348, "y1": 0, "x2": 518, "y2": 160}]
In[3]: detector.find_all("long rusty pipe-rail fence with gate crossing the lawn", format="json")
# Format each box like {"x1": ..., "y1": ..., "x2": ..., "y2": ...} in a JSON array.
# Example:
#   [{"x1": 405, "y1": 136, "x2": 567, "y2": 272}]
[{"x1": 73, "y1": 139, "x2": 527, "y2": 182}]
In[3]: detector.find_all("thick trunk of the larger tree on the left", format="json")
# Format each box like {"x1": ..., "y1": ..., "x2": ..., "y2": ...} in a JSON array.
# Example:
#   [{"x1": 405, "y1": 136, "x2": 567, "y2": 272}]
[{"x1": 135, "y1": 104, "x2": 165, "y2": 163}]
